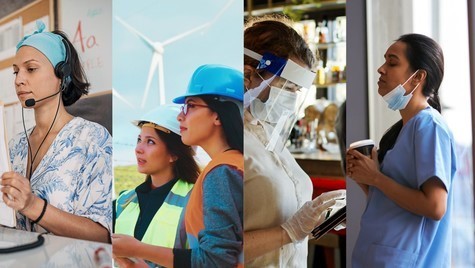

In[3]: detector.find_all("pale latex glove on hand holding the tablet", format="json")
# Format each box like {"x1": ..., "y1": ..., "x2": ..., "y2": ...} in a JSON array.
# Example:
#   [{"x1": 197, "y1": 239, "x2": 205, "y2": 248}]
[{"x1": 281, "y1": 190, "x2": 346, "y2": 243}]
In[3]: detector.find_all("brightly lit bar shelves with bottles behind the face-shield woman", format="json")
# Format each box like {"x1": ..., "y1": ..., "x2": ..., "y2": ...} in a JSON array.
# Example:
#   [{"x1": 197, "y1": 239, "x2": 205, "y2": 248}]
[{"x1": 244, "y1": 0, "x2": 347, "y2": 103}]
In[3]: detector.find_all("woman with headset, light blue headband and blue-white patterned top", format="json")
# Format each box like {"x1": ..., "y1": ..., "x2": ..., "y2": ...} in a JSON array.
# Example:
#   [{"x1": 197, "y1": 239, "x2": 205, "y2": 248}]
[{"x1": 1, "y1": 22, "x2": 112, "y2": 242}]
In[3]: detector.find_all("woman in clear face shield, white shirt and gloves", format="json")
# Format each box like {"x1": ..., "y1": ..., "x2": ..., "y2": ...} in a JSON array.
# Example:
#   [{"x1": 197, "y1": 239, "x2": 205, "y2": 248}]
[{"x1": 244, "y1": 17, "x2": 346, "y2": 267}]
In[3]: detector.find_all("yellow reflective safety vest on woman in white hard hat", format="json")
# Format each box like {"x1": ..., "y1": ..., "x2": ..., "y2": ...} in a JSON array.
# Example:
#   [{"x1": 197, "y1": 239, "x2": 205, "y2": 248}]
[{"x1": 115, "y1": 179, "x2": 193, "y2": 248}]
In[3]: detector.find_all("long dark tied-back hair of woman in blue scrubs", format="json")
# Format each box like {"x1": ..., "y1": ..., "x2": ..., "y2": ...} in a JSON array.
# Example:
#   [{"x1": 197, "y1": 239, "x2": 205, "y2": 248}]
[{"x1": 378, "y1": 34, "x2": 444, "y2": 163}]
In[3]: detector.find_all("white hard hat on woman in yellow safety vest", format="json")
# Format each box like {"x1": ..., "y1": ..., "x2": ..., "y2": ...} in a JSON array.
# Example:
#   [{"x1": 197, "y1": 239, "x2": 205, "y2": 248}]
[{"x1": 132, "y1": 104, "x2": 181, "y2": 135}]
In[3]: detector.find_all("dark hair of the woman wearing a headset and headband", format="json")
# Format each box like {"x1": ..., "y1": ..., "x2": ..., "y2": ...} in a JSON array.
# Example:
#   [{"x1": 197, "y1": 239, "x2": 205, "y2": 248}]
[{"x1": 52, "y1": 30, "x2": 90, "y2": 106}]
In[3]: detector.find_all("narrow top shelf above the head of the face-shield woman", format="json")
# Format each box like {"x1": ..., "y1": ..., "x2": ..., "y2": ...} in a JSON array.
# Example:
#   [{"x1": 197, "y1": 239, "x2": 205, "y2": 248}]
[{"x1": 244, "y1": 0, "x2": 346, "y2": 17}]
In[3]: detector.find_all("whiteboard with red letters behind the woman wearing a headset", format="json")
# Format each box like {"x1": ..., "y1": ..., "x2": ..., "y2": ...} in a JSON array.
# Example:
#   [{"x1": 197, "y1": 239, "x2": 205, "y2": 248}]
[{"x1": 58, "y1": 0, "x2": 112, "y2": 93}]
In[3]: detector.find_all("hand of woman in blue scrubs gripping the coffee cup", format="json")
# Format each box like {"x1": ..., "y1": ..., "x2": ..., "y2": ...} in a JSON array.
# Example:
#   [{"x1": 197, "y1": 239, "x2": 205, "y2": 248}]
[{"x1": 346, "y1": 148, "x2": 380, "y2": 185}]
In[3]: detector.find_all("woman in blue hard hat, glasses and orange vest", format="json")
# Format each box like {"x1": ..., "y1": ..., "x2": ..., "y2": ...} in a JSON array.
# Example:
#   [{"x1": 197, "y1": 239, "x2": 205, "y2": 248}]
[{"x1": 112, "y1": 65, "x2": 244, "y2": 267}]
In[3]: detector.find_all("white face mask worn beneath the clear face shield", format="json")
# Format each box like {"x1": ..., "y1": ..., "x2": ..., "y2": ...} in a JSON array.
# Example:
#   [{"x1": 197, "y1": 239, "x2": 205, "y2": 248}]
[{"x1": 251, "y1": 86, "x2": 297, "y2": 124}]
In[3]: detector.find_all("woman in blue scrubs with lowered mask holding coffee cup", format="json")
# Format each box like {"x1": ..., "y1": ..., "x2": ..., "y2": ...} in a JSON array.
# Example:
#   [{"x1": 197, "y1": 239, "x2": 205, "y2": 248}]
[{"x1": 346, "y1": 34, "x2": 456, "y2": 268}]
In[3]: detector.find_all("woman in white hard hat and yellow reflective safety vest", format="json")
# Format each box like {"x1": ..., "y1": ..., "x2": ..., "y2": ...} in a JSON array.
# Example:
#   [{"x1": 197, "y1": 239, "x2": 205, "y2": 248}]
[{"x1": 113, "y1": 105, "x2": 200, "y2": 263}]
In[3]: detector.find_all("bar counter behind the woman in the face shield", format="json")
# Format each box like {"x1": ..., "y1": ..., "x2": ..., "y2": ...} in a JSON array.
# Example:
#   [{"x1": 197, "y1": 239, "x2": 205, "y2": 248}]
[{"x1": 292, "y1": 150, "x2": 344, "y2": 179}]
